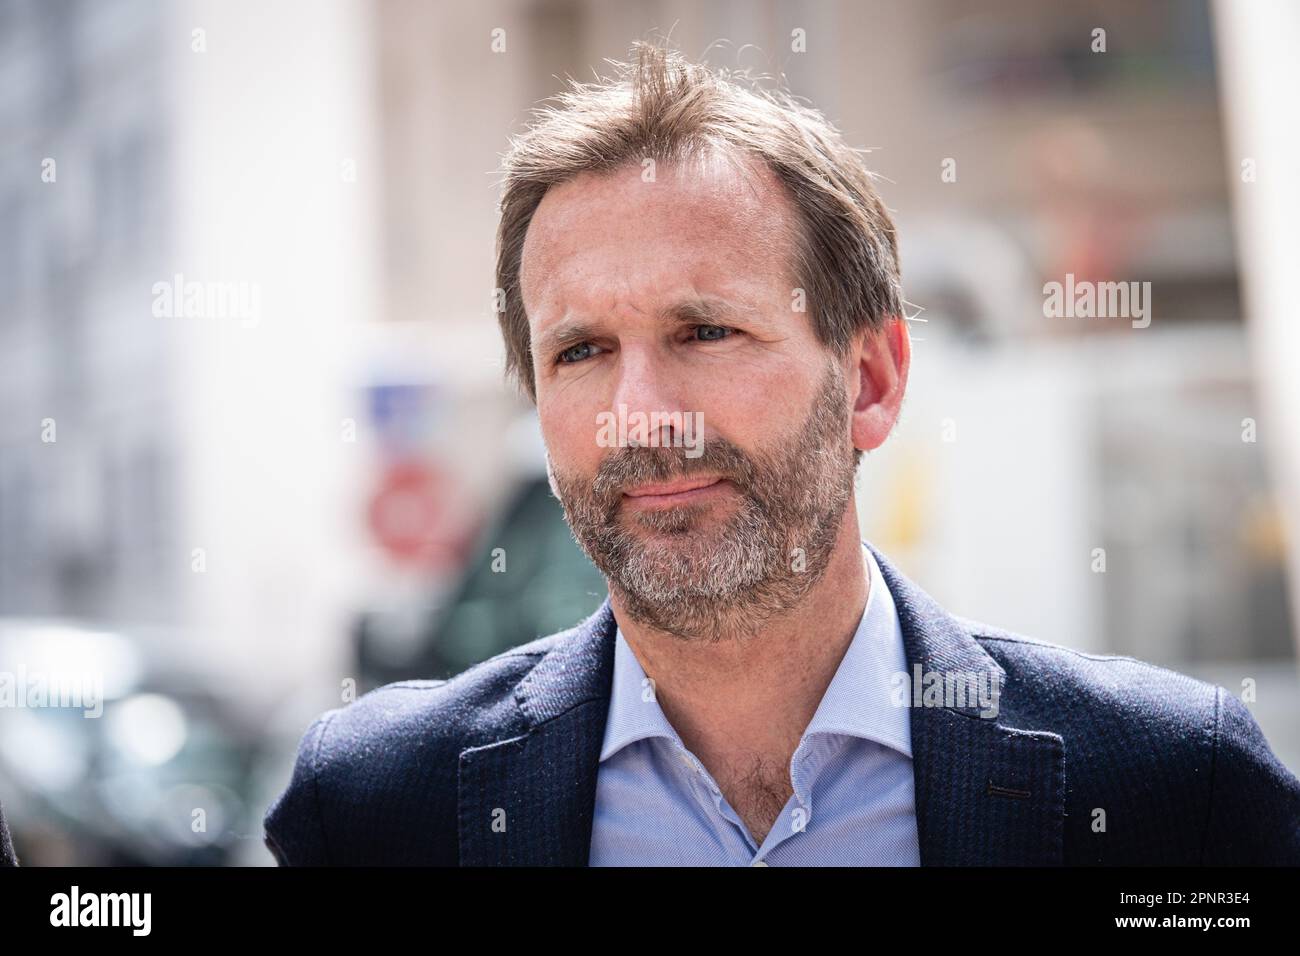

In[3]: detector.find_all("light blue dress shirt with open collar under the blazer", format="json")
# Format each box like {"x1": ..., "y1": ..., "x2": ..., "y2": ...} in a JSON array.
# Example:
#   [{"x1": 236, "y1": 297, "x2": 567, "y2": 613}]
[{"x1": 588, "y1": 545, "x2": 920, "y2": 866}]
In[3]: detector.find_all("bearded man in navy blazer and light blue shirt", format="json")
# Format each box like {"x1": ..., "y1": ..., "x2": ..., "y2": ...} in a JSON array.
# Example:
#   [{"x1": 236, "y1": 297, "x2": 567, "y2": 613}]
[{"x1": 267, "y1": 44, "x2": 1300, "y2": 865}]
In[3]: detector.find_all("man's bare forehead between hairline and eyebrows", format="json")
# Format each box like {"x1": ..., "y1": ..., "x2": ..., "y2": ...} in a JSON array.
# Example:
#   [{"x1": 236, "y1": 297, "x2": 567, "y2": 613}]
[{"x1": 520, "y1": 155, "x2": 797, "y2": 319}]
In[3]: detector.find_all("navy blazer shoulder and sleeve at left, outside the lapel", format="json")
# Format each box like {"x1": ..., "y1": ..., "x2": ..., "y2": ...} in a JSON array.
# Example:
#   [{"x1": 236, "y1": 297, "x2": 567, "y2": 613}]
[{"x1": 264, "y1": 631, "x2": 569, "y2": 865}]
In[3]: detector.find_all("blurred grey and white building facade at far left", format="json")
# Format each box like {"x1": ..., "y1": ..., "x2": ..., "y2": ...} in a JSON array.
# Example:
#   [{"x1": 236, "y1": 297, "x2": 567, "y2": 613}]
[{"x1": 0, "y1": 0, "x2": 373, "y2": 704}]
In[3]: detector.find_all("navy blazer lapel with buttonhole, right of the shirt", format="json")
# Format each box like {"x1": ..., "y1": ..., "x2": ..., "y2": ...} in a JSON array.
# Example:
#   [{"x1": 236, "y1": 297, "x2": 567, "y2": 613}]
[{"x1": 867, "y1": 544, "x2": 1065, "y2": 866}]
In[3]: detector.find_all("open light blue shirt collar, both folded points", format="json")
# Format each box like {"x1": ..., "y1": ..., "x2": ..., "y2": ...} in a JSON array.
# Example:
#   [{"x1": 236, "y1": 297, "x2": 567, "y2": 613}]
[{"x1": 601, "y1": 542, "x2": 911, "y2": 762}]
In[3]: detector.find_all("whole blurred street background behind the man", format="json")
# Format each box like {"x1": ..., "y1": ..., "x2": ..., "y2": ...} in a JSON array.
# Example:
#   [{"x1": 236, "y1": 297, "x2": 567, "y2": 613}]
[{"x1": 0, "y1": 0, "x2": 1300, "y2": 865}]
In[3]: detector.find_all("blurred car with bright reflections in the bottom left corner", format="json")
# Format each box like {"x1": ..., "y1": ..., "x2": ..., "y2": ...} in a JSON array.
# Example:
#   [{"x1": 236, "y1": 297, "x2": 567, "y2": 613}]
[{"x1": 0, "y1": 618, "x2": 260, "y2": 866}]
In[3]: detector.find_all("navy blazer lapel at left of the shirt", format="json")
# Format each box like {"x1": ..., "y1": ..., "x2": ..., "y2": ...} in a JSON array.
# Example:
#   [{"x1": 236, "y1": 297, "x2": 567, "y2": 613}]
[{"x1": 458, "y1": 598, "x2": 616, "y2": 866}]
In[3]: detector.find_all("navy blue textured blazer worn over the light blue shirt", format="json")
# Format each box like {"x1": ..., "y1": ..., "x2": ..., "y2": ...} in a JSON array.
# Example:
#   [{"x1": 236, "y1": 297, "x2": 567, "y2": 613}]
[{"x1": 265, "y1": 544, "x2": 1300, "y2": 866}]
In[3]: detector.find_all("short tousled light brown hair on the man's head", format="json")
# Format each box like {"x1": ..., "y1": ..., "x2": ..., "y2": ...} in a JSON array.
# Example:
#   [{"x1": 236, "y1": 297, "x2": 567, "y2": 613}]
[{"x1": 497, "y1": 42, "x2": 902, "y2": 402}]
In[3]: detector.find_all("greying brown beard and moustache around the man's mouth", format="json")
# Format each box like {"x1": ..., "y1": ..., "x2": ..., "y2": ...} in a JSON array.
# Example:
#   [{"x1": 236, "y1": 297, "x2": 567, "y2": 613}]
[{"x1": 551, "y1": 363, "x2": 857, "y2": 641}]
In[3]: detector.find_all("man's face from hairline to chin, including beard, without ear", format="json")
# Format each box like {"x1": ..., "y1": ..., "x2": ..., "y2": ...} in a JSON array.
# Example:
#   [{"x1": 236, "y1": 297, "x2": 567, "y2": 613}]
[{"x1": 521, "y1": 151, "x2": 855, "y2": 637}]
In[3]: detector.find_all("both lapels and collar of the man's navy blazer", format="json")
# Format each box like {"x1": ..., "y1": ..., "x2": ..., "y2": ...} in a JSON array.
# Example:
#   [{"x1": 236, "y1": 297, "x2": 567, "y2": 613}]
[{"x1": 459, "y1": 542, "x2": 1065, "y2": 866}]
